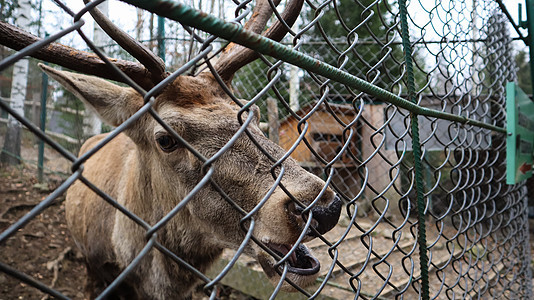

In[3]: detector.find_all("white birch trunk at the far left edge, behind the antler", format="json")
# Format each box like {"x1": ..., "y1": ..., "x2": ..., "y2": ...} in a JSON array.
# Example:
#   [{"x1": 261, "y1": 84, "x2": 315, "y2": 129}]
[{"x1": 0, "y1": 0, "x2": 31, "y2": 165}]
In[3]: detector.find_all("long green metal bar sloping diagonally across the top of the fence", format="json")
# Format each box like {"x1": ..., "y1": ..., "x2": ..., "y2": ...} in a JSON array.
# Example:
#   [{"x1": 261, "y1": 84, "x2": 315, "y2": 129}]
[{"x1": 122, "y1": 0, "x2": 506, "y2": 133}]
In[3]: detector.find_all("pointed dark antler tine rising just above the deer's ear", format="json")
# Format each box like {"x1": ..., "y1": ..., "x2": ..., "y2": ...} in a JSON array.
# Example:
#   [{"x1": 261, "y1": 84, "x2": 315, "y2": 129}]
[{"x1": 83, "y1": 0, "x2": 167, "y2": 85}]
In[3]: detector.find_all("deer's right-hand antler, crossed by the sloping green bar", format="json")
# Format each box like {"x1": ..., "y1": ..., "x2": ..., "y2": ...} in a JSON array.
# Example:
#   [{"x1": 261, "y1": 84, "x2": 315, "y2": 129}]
[{"x1": 215, "y1": 0, "x2": 304, "y2": 83}]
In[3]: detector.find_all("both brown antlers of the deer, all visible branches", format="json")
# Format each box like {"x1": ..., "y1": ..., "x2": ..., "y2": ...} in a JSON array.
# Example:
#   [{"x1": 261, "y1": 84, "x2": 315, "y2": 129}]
[{"x1": 0, "y1": 0, "x2": 304, "y2": 90}]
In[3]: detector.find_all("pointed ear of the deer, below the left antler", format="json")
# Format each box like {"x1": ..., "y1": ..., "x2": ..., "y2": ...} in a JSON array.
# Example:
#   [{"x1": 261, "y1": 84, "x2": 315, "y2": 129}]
[{"x1": 39, "y1": 64, "x2": 143, "y2": 126}]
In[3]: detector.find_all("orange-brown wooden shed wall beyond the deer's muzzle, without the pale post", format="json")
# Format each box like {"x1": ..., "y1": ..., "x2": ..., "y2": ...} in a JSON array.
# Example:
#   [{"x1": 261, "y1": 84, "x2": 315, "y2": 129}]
[{"x1": 272, "y1": 103, "x2": 361, "y2": 198}]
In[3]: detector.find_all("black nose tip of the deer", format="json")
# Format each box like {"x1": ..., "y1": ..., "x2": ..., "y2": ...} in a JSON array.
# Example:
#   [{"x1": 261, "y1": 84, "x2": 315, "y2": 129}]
[{"x1": 296, "y1": 195, "x2": 341, "y2": 236}]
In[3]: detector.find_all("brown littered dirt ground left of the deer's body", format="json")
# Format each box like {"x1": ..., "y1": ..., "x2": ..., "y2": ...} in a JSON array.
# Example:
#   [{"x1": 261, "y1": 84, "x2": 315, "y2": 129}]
[{"x1": 0, "y1": 168, "x2": 85, "y2": 300}]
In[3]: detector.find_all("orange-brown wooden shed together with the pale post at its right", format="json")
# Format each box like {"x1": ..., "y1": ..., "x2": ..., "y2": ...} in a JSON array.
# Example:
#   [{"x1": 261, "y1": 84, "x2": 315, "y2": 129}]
[{"x1": 272, "y1": 103, "x2": 398, "y2": 214}]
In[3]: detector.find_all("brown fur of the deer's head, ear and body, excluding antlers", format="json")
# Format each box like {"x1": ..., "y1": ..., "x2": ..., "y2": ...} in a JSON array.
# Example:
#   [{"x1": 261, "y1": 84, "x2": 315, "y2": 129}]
[{"x1": 41, "y1": 65, "x2": 340, "y2": 299}]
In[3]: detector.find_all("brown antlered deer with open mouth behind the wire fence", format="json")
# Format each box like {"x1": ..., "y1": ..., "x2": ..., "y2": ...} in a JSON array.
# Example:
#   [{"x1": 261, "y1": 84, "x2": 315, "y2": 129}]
[{"x1": 0, "y1": 0, "x2": 342, "y2": 299}]
